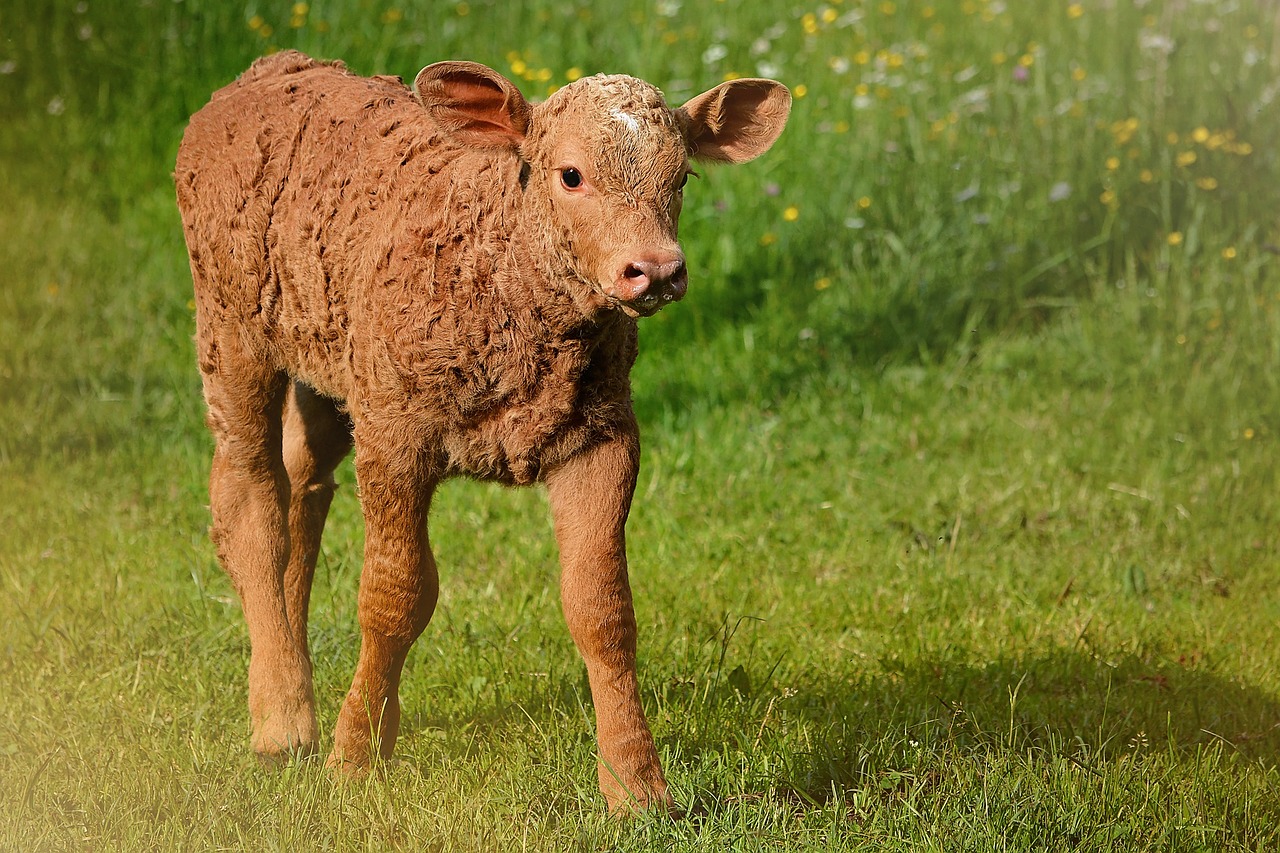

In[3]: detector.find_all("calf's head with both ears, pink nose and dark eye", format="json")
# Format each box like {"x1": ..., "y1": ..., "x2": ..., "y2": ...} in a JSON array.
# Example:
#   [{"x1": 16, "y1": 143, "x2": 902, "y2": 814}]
[{"x1": 413, "y1": 61, "x2": 791, "y2": 316}]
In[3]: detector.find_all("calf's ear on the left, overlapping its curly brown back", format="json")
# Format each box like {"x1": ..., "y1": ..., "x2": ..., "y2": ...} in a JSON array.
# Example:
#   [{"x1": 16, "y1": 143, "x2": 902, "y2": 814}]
[{"x1": 413, "y1": 61, "x2": 530, "y2": 149}]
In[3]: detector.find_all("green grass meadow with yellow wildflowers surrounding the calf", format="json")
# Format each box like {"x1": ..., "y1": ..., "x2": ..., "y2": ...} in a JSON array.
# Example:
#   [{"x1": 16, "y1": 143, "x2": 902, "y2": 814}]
[{"x1": 0, "y1": 0, "x2": 1280, "y2": 850}]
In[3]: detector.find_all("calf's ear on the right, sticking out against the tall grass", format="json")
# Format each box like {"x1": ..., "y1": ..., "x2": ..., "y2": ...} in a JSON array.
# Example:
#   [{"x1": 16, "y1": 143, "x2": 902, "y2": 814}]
[{"x1": 678, "y1": 78, "x2": 791, "y2": 163}]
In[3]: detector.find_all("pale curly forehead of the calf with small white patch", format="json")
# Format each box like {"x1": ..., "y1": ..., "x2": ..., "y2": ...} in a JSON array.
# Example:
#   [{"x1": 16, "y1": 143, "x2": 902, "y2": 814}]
[{"x1": 529, "y1": 74, "x2": 689, "y2": 192}]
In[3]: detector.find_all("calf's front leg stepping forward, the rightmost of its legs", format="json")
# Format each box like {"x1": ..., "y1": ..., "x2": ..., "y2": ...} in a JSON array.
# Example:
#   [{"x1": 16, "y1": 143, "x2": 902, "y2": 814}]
[{"x1": 547, "y1": 434, "x2": 672, "y2": 812}]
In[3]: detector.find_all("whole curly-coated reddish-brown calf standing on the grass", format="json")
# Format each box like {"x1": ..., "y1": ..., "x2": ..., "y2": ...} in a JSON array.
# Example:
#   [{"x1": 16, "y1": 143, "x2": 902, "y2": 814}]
[{"x1": 174, "y1": 51, "x2": 790, "y2": 809}]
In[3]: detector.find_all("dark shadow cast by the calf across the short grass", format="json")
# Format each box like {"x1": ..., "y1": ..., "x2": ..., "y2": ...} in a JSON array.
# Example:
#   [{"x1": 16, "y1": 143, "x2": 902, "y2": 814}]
[{"x1": 403, "y1": 648, "x2": 1280, "y2": 817}]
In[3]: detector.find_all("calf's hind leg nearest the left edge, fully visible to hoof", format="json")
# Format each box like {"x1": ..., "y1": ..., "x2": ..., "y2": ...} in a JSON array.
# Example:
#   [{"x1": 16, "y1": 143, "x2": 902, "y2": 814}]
[{"x1": 198, "y1": 328, "x2": 316, "y2": 760}]
